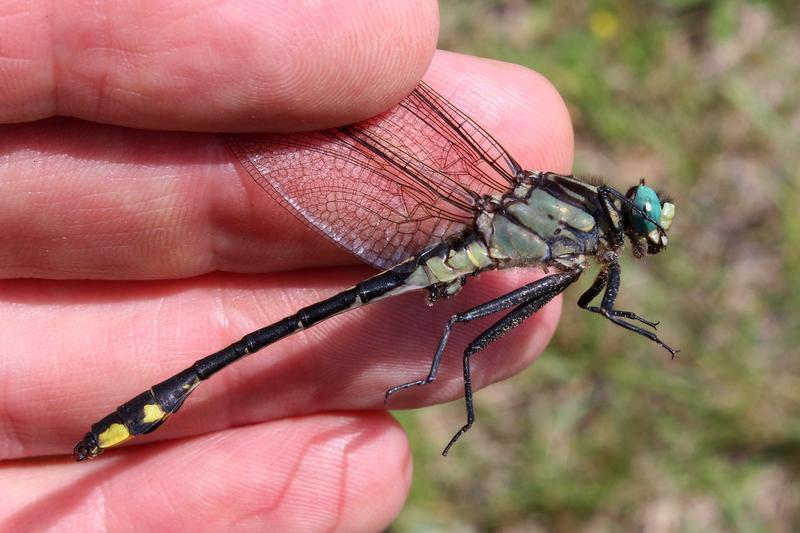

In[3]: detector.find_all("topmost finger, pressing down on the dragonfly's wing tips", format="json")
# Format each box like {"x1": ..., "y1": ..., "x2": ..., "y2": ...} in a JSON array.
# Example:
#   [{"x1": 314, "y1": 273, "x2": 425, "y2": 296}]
[{"x1": 0, "y1": 0, "x2": 438, "y2": 131}]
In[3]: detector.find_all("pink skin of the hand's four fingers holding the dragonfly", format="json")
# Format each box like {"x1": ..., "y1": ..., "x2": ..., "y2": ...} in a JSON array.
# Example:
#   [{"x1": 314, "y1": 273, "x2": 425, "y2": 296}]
[{"x1": 0, "y1": 1, "x2": 572, "y2": 531}]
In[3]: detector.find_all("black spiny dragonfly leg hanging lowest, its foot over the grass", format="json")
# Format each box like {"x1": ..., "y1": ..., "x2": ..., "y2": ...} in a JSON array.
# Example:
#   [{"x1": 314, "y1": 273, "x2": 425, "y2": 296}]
[{"x1": 442, "y1": 269, "x2": 581, "y2": 455}]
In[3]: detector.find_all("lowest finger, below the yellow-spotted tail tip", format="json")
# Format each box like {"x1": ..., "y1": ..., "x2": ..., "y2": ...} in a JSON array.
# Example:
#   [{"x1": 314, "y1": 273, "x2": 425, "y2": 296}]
[{"x1": 0, "y1": 414, "x2": 411, "y2": 531}]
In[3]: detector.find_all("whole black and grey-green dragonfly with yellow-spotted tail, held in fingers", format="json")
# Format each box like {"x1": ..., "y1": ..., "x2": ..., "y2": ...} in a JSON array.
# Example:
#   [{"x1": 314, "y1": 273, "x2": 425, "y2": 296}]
[{"x1": 73, "y1": 82, "x2": 677, "y2": 461}]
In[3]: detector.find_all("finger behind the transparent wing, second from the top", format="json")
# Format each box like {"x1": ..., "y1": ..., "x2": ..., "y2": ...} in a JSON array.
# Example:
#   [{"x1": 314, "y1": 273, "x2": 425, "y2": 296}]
[{"x1": 0, "y1": 53, "x2": 572, "y2": 279}]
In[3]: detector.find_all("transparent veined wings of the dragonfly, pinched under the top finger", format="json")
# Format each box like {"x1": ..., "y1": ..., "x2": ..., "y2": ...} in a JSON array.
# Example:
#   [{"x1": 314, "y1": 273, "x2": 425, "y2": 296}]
[{"x1": 224, "y1": 83, "x2": 520, "y2": 269}]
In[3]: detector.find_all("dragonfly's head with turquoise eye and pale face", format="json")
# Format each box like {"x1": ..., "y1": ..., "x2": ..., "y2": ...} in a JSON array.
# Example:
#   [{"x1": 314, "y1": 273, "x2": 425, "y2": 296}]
[{"x1": 625, "y1": 180, "x2": 675, "y2": 257}]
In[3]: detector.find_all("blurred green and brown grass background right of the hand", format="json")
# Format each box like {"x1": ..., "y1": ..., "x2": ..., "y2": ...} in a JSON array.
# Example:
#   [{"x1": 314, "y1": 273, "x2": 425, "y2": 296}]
[{"x1": 392, "y1": 0, "x2": 800, "y2": 532}]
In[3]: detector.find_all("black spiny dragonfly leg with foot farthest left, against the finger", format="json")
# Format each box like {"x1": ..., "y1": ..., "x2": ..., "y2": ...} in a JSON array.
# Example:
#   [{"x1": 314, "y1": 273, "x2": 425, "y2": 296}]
[{"x1": 383, "y1": 270, "x2": 580, "y2": 405}]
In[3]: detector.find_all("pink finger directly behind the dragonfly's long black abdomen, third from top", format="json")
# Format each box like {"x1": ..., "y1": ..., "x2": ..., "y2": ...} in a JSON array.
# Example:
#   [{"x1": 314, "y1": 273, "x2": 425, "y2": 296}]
[{"x1": 0, "y1": 268, "x2": 559, "y2": 458}]
